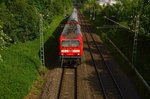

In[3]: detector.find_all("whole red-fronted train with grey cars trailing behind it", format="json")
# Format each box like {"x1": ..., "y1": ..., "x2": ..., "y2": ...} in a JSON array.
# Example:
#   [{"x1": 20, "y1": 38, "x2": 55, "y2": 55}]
[{"x1": 59, "y1": 8, "x2": 83, "y2": 64}]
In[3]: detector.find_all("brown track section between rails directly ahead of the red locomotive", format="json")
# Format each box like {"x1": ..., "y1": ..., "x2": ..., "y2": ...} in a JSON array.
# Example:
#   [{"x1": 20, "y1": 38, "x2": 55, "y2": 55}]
[{"x1": 58, "y1": 67, "x2": 77, "y2": 99}]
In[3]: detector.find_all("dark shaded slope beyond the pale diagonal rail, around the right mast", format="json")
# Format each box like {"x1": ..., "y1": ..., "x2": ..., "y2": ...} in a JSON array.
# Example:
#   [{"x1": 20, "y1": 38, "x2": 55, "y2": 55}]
[{"x1": 105, "y1": 30, "x2": 150, "y2": 84}]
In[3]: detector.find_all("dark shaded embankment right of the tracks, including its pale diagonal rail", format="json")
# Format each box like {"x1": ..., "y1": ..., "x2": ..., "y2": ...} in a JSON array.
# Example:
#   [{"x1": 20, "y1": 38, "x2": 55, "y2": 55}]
[{"x1": 99, "y1": 32, "x2": 150, "y2": 99}]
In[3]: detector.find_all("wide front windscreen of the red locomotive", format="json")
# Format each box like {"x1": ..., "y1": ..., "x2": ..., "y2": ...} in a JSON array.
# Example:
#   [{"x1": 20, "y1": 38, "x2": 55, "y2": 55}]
[{"x1": 62, "y1": 40, "x2": 80, "y2": 47}]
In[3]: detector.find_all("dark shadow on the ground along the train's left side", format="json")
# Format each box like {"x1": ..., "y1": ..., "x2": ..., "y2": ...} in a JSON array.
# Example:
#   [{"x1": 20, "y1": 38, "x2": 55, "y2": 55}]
[{"x1": 44, "y1": 18, "x2": 68, "y2": 69}]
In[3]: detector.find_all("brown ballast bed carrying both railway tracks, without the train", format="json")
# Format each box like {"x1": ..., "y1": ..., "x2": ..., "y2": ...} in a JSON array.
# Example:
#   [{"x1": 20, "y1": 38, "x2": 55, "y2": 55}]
[{"x1": 38, "y1": 8, "x2": 139, "y2": 99}]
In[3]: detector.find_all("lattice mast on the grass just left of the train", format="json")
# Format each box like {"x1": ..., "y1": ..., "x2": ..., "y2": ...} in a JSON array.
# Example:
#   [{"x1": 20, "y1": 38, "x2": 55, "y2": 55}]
[{"x1": 39, "y1": 14, "x2": 45, "y2": 66}]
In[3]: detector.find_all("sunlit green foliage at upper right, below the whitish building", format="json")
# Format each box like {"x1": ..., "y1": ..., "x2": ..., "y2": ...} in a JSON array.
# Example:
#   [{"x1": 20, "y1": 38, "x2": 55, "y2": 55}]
[{"x1": 82, "y1": 0, "x2": 150, "y2": 37}]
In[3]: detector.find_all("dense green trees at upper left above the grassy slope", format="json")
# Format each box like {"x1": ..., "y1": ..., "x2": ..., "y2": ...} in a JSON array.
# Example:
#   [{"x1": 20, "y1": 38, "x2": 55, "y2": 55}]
[{"x1": 0, "y1": 0, "x2": 72, "y2": 46}]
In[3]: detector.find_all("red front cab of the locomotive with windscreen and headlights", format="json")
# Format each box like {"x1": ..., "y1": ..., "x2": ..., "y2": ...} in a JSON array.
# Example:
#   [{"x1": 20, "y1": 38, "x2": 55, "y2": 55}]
[{"x1": 60, "y1": 38, "x2": 83, "y2": 64}]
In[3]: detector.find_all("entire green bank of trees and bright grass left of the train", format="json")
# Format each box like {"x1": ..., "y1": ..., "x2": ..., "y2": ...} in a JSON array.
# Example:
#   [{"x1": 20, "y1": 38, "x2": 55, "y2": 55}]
[{"x1": 0, "y1": 0, "x2": 72, "y2": 99}]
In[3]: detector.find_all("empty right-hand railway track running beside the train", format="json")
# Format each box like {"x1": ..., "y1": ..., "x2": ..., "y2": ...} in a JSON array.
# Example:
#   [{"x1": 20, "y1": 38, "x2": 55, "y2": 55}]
[{"x1": 79, "y1": 10, "x2": 124, "y2": 99}]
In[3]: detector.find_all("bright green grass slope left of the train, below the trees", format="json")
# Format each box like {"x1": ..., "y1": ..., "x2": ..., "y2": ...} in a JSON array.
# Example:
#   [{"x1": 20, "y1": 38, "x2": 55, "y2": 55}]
[{"x1": 0, "y1": 16, "x2": 63, "y2": 99}]
